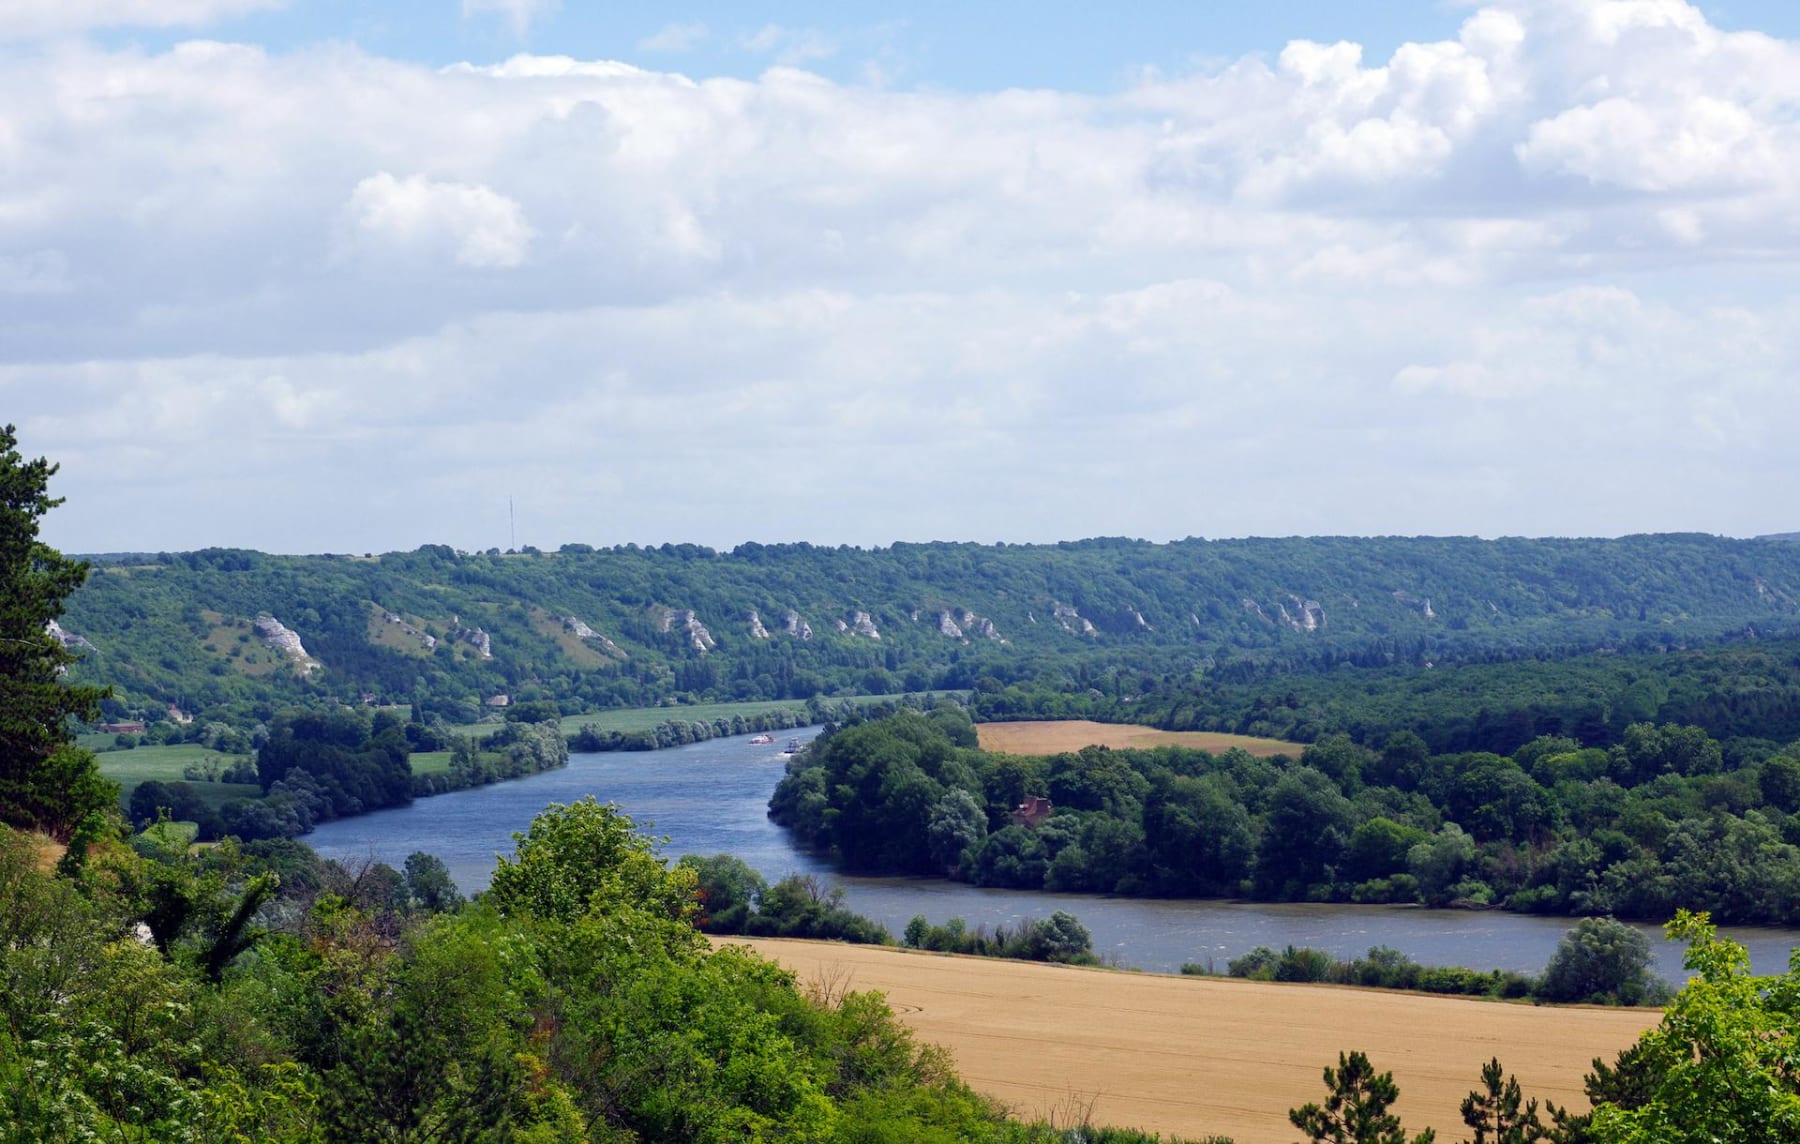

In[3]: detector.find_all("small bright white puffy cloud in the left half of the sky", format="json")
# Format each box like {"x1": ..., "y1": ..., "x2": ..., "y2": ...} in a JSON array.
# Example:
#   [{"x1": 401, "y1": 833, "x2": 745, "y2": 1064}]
[{"x1": 346, "y1": 171, "x2": 533, "y2": 268}]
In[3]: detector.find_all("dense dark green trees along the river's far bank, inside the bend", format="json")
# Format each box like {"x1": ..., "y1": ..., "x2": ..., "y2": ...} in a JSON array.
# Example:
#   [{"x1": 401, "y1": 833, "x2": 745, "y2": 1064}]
[{"x1": 770, "y1": 707, "x2": 1800, "y2": 925}]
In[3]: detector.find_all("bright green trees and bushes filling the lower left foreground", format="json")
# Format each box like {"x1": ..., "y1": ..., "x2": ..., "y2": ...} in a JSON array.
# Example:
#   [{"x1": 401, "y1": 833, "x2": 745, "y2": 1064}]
[{"x1": 0, "y1": 800, "x2": 1216, "y2": 1144}]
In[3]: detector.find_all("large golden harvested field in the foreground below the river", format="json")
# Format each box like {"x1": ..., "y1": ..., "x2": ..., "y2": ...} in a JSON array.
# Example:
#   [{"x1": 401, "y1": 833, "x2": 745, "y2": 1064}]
[{"x1": 722, "y1": 939, "x2": 1661, "y2": 1144}]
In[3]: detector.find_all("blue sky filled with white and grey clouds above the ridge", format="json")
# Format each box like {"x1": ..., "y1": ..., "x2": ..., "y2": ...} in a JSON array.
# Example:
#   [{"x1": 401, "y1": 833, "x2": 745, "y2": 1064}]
[{"x1": 0, "y1": 0, "x2": 1800, "y2": 552}]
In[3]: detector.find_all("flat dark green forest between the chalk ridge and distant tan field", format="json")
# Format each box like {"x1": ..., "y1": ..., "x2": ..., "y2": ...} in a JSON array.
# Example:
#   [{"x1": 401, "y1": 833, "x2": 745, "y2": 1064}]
[{"x1": 976, "y1": 635, "x2": 1800, "y2": 755}]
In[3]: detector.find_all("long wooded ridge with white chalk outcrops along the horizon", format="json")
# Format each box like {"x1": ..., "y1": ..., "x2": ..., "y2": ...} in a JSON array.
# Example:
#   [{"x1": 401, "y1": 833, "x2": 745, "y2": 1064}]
[{"x1": 58, "y1": 534, "x2": 1800, "y2": 727}]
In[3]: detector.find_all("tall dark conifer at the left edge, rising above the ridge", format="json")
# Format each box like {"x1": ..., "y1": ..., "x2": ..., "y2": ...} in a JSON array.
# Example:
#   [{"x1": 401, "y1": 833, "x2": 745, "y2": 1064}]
[{"x1": 0, "y1": 425, "x2": 119, "y2": 838}]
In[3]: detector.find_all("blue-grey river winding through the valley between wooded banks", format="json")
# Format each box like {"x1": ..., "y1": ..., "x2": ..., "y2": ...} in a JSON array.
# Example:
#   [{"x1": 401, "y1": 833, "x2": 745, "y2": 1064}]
[{"x1": 304, "y1": 728, "x2": 1800, "y2": 980}]
